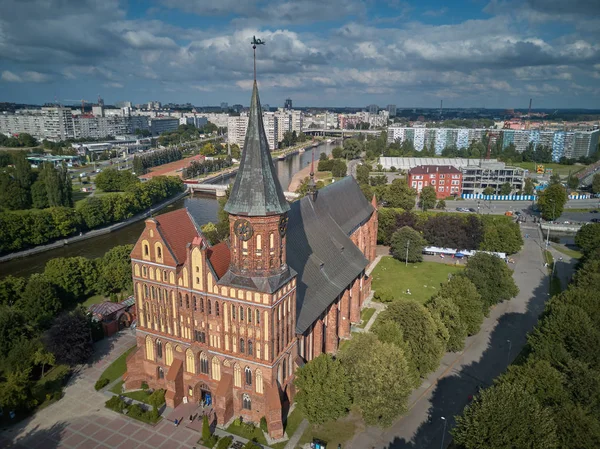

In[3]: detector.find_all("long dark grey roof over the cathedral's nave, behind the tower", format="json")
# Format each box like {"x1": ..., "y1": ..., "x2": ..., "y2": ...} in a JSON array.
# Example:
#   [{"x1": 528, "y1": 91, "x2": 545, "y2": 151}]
[{"x1": 286, "y1": 177, "x2": 373, "y2": 333}]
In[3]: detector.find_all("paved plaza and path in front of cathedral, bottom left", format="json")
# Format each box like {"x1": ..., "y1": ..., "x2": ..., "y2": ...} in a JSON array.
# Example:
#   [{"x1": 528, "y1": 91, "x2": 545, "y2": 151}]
[{"x1": 0, "y1": 331, "x2": 200, "y2": 449}]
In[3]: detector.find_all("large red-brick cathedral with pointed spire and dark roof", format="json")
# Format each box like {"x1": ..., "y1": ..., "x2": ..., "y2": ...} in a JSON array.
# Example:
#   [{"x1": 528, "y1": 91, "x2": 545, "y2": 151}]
[{"x1": 124, "y1": 81, "x2": 377, "y2": 438}]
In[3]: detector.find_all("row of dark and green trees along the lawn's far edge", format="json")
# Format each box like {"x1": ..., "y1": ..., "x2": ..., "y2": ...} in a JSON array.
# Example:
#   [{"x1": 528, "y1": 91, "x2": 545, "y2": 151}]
[{"x1": 377, "y1": 208, "x2": 523, "y2": 254}]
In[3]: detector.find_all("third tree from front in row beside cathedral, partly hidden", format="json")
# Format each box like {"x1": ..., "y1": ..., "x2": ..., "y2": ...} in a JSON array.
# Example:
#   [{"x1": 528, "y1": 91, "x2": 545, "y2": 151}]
[{"x1": 379, "y1": 300, "x2": 446, "y2": 377}]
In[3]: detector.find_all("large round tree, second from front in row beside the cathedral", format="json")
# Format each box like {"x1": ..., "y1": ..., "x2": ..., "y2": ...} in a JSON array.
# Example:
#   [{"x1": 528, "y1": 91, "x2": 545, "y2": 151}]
[{"x1": 339, "y1": 334, "x2": 414, "y2": 426}]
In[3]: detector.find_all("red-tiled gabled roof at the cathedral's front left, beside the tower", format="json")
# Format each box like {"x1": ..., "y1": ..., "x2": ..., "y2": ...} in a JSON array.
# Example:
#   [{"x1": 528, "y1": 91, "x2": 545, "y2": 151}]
[{"x1": 154, "y1": 208, "x2": 201, "y2": 264}]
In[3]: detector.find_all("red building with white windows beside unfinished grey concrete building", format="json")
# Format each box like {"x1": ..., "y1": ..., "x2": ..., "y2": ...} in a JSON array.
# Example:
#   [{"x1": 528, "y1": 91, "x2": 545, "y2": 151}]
[{"x1": 408, "y1": 165, "x2": 462, "y2": 199}]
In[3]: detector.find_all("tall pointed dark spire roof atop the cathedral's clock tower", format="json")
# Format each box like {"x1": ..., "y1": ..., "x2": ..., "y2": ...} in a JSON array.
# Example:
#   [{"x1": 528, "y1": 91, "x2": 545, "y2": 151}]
[{"x1": 225, "y1": 81, "x2": 290, "y2": 216}]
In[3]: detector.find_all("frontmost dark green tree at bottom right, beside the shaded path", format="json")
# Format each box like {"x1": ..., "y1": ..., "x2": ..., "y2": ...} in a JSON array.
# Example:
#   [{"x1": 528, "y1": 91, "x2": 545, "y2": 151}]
[{"x1": 451, "y1": 383, "x2": 558, "y2": 449}]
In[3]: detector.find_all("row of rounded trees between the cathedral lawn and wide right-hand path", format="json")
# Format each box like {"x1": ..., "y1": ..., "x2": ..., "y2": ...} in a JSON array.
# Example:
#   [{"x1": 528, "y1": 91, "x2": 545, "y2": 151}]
[{"x1": 295, "y1": 254, "x2": 518, "y2": 426}]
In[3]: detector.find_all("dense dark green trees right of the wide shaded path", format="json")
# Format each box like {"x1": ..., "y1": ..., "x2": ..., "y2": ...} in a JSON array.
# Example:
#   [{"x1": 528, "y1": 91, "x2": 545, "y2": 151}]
[{"x1": 452, "y1": 228, "x2": 600, "y2": 449}]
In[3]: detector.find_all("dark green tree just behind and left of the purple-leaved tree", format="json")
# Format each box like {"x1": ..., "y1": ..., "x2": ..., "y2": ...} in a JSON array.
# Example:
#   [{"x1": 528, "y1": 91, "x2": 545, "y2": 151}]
[{"x1": 15, "y1": 273, "x2": 62, "y2": 328}]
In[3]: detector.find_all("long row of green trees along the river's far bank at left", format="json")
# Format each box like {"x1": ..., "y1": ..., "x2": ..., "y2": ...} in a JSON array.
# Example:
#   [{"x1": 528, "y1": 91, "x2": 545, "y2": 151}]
[{"x1": 0, "y1": 176, "x2": 183, "y2": 253}]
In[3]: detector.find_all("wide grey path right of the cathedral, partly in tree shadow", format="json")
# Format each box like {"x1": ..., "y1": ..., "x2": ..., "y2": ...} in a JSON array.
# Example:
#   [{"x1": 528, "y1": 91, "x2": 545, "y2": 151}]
[{"x1": 347, "y1": 227, "x2": 564, "y2": 449}]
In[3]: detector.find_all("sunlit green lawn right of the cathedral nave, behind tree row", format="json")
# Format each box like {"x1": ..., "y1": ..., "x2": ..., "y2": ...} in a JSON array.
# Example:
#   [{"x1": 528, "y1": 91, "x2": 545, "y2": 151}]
[{"x1": 372, "y1": 256, "x2": 463, "y2": 303}]
